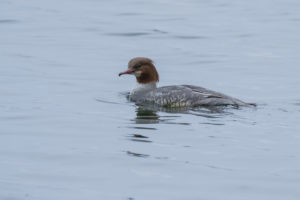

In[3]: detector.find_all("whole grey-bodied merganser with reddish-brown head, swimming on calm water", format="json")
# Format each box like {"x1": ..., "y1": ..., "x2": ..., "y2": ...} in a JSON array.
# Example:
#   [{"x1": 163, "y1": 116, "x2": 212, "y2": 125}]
[{"x1": 119, "y1": 57, "x2": 255, "y2": 107}]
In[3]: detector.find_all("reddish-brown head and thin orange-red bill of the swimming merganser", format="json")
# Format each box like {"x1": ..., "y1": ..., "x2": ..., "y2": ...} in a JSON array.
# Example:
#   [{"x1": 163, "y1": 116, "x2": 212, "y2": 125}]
[{"x1": 119, "y1": 57, "x2": 159, "y2": 84}]
